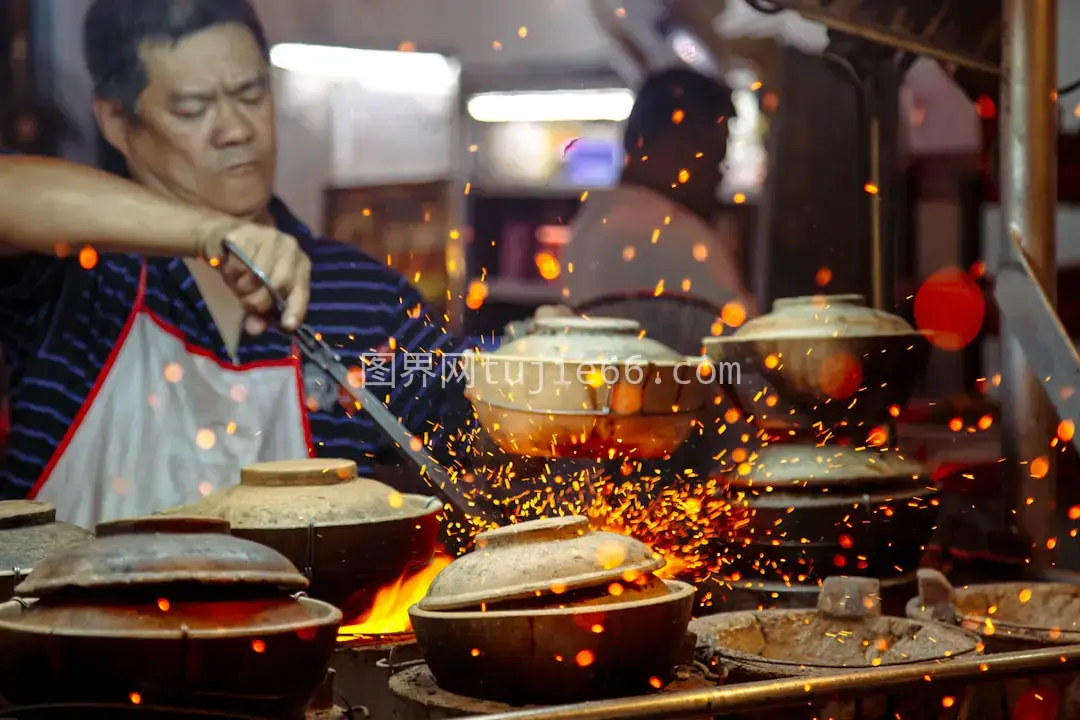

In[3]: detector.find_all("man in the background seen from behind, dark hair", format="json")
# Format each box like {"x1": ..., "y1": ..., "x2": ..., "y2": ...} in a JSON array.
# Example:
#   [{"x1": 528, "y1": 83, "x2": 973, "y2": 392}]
[{"x1": 564, "y1": 68, "x2": 752, "y2": 321}]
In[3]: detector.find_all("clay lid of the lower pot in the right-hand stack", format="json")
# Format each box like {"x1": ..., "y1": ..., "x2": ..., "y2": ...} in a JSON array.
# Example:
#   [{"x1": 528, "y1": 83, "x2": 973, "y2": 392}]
[{"x1": 729, "y1": 443, "x2": 927, "y2": 488}]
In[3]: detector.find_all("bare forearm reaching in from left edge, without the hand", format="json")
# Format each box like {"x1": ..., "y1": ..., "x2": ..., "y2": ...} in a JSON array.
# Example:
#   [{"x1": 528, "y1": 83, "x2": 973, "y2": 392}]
[{"x1": 0, "y1": 155, "x2": 231, "y2": 257}]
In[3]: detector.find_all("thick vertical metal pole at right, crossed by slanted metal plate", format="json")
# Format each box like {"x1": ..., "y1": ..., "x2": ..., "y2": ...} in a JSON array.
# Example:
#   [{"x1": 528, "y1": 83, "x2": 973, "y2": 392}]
[{"x1": 1000, "y1": 0, "x2": 1057, "y2": 569}]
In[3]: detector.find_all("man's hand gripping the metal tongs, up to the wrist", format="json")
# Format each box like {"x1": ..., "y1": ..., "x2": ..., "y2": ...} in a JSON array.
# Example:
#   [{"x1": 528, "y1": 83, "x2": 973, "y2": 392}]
[{"x1": 202, "y1": 222, "x2": 311, "y2": 335}]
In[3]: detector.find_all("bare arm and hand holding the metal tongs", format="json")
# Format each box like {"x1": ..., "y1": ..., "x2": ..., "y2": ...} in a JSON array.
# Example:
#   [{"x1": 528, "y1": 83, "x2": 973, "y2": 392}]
[{"x1": 0, "y1": 153, "x2": 311, "y2": 334}]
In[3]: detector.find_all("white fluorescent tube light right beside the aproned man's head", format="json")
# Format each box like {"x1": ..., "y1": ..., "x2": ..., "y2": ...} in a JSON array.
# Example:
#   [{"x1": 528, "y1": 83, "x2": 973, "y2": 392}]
[{"x1": 270, "y1": 43, "x2": 460, "y2": 93}]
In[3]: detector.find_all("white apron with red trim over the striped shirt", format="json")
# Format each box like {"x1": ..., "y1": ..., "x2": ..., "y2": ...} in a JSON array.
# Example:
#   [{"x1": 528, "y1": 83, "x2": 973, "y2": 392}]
[{"x1": 30, "y1": 263, "x2": 313, "y2": 528}]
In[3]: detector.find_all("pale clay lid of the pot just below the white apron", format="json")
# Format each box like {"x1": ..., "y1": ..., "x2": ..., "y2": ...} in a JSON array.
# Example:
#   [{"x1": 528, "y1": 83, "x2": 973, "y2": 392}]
[{"x1": 155, "y1": 458, "x2": 442, "y2": 530}]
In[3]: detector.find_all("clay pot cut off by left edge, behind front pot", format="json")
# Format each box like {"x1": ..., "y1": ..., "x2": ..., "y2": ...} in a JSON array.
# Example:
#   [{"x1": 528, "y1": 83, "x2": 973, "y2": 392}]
[{"x1": 0, "y1": 500, "x2": 94, "y2": 602}]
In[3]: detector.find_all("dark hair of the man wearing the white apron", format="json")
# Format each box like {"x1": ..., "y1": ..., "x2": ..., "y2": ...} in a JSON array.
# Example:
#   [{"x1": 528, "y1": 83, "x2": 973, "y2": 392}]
[{"x1": 83, "y1": 0, "x2": 269, "y2": 118}]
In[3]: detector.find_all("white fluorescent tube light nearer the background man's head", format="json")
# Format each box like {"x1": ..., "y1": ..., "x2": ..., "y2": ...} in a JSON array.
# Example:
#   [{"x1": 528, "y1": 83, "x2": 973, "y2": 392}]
[{"x1": 468, "y1": 90, "x2": 634, "y2": 122}]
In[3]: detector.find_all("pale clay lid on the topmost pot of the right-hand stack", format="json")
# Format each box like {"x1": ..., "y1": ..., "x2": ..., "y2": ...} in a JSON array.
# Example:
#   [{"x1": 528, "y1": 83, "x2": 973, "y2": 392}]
[{"x1": 733, "y1": 295, "x2": 916, "y2": 340}]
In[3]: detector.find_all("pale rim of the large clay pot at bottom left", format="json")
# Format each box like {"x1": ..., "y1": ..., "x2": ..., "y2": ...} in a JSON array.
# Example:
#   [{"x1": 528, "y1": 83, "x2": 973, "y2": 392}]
[{"x1": 0, "y1": 596, "x2": 343, "y2": 640}]
